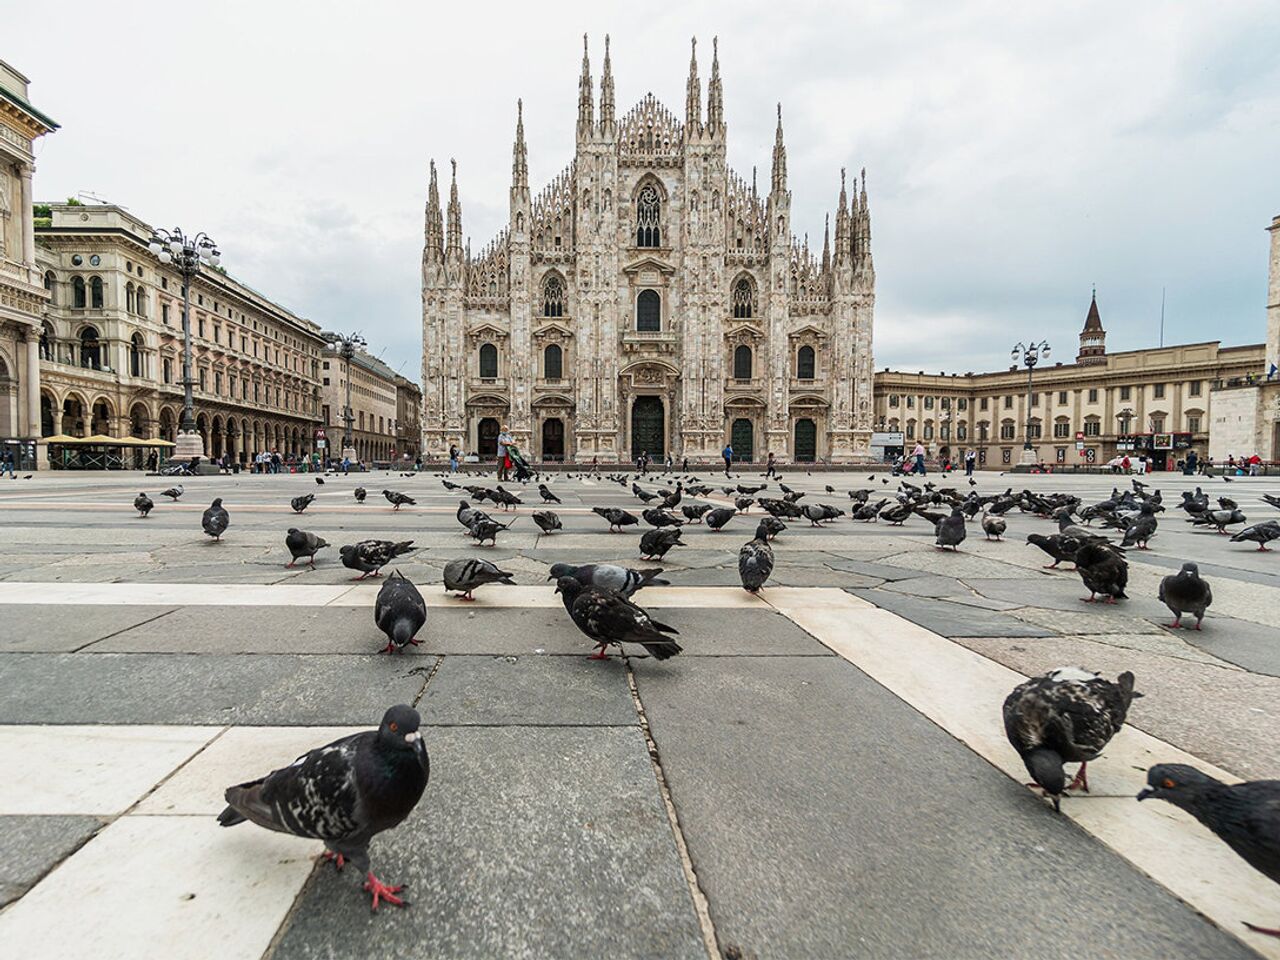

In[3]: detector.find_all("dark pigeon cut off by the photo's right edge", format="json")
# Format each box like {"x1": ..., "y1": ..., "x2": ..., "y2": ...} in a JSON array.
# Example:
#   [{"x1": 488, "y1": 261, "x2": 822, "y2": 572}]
[{"x1": 1138, "y1": 763, "x2": 1280, "y2": 937}]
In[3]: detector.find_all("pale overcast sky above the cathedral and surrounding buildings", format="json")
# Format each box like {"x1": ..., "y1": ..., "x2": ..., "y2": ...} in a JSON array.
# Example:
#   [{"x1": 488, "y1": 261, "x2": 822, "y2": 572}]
[{"x1": 0, "y1": 0, "x2": 1280, "y2": 379}]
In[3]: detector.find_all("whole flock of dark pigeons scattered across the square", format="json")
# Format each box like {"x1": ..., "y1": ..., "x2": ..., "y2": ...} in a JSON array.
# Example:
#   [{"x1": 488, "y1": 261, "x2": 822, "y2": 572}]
[{"x1": 122, "y1": 465, "x2": 1280, "y2": 936}]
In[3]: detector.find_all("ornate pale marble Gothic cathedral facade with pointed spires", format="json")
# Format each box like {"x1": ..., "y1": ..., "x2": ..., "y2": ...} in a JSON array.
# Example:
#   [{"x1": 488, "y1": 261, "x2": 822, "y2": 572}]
[{"x1": 422, "y1": 38, "x2": 876, "y2": 462}]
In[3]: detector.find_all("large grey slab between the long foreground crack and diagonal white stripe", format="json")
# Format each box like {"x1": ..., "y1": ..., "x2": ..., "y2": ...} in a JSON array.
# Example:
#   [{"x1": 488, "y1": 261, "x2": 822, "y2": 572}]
[{"x1": 637, "y1": 658, "x2": 1252, "y2": 960}]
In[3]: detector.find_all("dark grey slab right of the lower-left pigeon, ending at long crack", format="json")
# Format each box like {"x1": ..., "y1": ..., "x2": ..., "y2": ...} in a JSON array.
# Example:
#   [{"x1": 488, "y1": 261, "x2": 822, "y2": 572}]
[{"x1": 274, "y1": 727, "x2": 707, "y2": 960}]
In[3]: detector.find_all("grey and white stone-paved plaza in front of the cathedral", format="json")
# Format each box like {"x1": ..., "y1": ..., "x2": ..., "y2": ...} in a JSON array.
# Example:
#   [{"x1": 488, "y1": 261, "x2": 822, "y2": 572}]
[{"x1": 0, "y1": 470, "x2": 1280, "y2": 960}]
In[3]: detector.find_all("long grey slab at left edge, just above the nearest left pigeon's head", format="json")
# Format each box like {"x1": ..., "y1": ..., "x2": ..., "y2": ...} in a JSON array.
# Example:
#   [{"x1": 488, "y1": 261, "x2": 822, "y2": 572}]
[{"x1": 0, "y1": 653, "x2": 436, "y2": 726}]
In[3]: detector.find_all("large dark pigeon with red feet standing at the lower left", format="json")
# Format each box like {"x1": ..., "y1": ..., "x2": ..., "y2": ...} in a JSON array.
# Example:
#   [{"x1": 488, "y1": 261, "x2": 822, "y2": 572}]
[{"x1": 218, "y1": 704, "x2": 430, "y2": 910}]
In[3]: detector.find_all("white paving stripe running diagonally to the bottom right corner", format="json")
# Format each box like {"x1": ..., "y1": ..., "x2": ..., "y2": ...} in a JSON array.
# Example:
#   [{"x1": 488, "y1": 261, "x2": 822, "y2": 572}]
[{"x1": 767, "y1": 588, "x2": 1280, "y2": 960}]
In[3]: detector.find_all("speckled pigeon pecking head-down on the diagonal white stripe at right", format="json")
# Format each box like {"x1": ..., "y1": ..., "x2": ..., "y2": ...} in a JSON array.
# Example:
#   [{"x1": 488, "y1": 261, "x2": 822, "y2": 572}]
[{"x1": 1004, "y1": 667, "x2": 1142, "y2": 810}]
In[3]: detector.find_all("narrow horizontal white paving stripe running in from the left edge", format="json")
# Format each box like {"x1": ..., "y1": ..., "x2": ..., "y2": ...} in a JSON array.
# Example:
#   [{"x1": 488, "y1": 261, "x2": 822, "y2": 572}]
[{"x1": 0, "y1": 579, "x2": 768, "y2": 611}]
